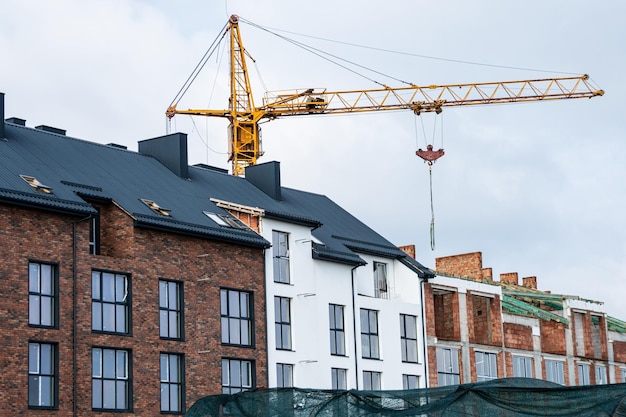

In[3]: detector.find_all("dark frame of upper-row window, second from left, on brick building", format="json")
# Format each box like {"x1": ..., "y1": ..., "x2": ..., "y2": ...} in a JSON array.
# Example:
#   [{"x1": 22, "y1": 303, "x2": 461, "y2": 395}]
[{"x1": 91, "y1": 269, "x2": 132, "y2": 336}]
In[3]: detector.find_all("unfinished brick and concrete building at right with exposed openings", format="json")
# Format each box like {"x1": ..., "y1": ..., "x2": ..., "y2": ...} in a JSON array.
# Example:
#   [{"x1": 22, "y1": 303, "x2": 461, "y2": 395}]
[{"x1": 424, "y1": 252, "x2": 626, "y2": 387}]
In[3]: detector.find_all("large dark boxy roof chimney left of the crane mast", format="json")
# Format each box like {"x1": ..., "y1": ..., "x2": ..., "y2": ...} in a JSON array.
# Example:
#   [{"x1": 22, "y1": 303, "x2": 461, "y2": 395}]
[{"x1": 138, "y1": 133, "x2": 189, "y2": 178}]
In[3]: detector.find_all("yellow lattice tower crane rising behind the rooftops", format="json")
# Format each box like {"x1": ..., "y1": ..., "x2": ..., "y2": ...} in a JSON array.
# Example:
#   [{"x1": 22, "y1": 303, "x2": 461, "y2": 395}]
[{"x1": 166, "y1": 15, "x2": 604, "y2": 176}]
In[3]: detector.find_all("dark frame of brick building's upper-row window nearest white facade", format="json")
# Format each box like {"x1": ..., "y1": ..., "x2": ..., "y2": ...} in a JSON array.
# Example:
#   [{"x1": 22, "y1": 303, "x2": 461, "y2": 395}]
[{"x1": 220, "y1": 288, "x2": 255, "y2": 348}]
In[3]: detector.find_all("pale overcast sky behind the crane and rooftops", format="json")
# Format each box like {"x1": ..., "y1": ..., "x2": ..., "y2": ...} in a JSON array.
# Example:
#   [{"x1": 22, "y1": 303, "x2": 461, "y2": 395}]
[{"x1": 0, "y1": 0, "x2": 626, "y2": 320}]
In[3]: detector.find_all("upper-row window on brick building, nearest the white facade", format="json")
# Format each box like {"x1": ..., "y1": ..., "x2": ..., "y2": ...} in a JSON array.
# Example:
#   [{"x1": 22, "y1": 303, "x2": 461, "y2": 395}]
[{"x1": 220, "y1": 289, "x2": 253, "y2": 346}]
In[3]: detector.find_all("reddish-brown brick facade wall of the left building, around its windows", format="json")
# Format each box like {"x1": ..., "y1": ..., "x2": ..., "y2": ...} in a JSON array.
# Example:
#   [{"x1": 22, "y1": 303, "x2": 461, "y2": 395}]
[{"x1": 0, "y1": 201, "x2": 267, "y2": 416}]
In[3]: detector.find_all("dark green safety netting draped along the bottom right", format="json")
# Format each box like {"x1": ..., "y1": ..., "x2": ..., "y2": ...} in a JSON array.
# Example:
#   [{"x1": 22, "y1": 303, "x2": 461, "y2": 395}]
[{"x1": 185, "y1": 378, "x2": 626, "y2": 417}]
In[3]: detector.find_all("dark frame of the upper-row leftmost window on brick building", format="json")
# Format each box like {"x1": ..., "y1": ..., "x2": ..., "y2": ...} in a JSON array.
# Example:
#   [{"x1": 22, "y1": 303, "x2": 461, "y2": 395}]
[{"x1": 28, "y1": 259, "x2": 59, "y2": 329}]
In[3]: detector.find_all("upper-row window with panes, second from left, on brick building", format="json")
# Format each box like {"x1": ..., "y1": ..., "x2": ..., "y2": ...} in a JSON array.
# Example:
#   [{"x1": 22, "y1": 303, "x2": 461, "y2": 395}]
[{"x1": 91, "y1": 271, "x2": 130, "y2": 334}]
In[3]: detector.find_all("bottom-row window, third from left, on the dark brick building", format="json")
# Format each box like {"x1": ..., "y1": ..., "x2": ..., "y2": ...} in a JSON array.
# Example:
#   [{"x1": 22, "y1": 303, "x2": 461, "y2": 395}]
[{"x1": 161, "y1": 353, "x2": 185, "y2": 412}]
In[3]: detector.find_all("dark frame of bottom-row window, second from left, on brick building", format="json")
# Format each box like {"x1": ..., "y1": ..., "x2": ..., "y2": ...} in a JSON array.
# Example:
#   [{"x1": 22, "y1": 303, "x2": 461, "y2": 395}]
[{"x1": 91, "y1": 346, "x2": 133, "y2": 412}]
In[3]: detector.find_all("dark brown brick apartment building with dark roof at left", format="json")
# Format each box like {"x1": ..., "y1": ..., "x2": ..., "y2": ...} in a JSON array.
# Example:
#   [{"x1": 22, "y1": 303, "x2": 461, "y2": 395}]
[{"x1": 0, "y1": 95, "x2": 269, "y2": 416}]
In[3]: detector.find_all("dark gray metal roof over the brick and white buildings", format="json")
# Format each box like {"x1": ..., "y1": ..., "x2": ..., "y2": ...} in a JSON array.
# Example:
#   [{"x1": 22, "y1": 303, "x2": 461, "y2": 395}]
[{"x1": 0, "y1": 123, "x2": 432, "y2": 275}]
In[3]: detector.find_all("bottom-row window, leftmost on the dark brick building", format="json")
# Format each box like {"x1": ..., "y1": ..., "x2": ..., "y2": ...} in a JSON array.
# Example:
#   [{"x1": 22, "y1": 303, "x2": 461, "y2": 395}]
[{"x1": 28, "y1": 342, "x2": 58, "y2": 408}]
